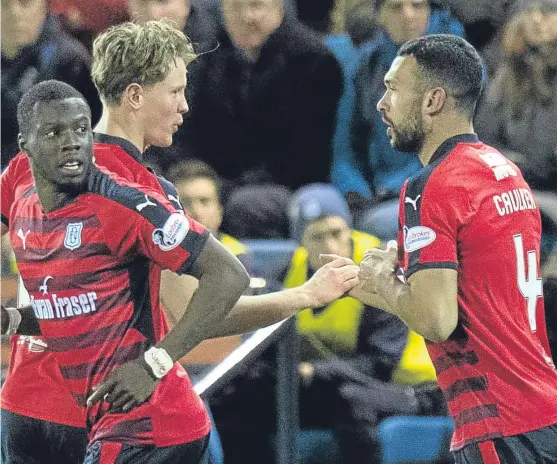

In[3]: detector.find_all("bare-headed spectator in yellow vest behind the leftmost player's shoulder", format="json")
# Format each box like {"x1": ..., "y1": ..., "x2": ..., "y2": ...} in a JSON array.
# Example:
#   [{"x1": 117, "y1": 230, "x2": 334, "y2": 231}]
[{"x1": 169, "y1": 160, "x2": 250, "y2": 272}]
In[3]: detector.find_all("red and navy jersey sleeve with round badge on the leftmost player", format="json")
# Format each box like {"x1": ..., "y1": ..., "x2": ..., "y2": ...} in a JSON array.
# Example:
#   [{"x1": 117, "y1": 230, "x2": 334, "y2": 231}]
[{"x1": 92, "y1": 179, "x2": 209, "y2": 274}]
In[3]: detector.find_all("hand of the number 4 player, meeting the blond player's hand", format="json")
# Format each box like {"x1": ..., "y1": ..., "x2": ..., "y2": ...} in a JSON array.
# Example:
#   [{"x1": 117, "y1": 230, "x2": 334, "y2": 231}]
[{"x1": 360, "y1": 240, "x2": 398, "y2": 294}]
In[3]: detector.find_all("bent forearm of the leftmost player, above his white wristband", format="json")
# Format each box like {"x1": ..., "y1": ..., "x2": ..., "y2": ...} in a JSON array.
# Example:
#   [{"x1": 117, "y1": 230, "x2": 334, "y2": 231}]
[{"x1": 157, "y1": 268, "x2": 249, "y2": 361}]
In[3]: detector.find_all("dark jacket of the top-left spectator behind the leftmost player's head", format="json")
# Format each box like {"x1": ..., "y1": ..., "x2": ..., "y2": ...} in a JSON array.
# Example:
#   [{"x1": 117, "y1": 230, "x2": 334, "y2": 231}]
[{"x1": 2, "y1": 15, "x2": 101, "y2": 167}]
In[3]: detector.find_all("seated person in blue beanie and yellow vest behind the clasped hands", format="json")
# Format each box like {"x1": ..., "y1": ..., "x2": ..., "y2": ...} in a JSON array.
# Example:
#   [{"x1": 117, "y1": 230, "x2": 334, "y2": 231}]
[{"x1": 284, "y1": 184, "x2": 446, "y2": 464}]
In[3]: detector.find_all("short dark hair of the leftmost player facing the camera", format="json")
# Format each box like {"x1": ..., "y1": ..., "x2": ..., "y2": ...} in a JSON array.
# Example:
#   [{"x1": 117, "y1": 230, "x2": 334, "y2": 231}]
[{"x1": 17, "y1": 80, "x2": 91, "y2": 134}]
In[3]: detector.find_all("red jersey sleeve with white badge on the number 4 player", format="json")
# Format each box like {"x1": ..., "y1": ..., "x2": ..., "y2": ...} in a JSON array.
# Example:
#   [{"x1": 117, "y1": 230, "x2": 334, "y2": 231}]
[{"x1": 399, "y1": 172, "x2": 469, "y2": 277}]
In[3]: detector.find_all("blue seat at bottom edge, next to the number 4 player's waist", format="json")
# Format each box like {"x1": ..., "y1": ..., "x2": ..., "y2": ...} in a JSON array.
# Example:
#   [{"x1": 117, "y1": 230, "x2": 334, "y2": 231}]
[{"x1": 377, "y1": 416, "x2": 454, "y2": 464}]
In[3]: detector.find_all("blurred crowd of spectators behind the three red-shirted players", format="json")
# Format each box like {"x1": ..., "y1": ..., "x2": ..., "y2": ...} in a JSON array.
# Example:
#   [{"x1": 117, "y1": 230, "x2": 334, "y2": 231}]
[{"x1": 1, "y1": 0, "x2": 557, "y2": 463}]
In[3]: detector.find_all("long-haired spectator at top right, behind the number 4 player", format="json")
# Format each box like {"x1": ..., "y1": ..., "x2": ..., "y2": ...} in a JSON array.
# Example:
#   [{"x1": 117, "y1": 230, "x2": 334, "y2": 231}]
[{"x1": 475, "y1": 1, "x2": 557, "y2": 193}]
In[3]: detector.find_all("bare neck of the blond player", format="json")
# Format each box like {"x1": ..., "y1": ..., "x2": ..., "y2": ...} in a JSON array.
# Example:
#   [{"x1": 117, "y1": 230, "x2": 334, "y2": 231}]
[{"x1": 94, "y1": 103, "x2": 147, "y2": 153}]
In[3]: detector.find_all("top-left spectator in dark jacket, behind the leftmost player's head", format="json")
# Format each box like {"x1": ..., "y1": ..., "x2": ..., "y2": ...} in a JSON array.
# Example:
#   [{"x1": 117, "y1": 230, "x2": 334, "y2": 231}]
[{"x1": 1, "y1": 0, "x2": 100, "y2": 167}]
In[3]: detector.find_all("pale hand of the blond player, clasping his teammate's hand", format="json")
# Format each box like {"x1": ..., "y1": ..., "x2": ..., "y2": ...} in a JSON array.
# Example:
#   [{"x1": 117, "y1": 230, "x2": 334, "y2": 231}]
[{"x1": 302, "y1": 255, "x2": 360, "y2": 308}]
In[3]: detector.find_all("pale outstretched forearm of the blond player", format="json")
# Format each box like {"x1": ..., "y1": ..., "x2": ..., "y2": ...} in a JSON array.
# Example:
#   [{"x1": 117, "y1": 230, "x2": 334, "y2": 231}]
[{"x1": 211, "y1": 287, "x2": 314, "y2": 337}]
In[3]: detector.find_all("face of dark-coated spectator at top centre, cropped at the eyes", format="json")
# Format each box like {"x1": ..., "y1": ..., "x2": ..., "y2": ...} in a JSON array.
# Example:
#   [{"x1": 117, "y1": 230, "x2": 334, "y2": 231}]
[{"x1": 222, "y1": 0, "x2": 284, "y2": 58}]
